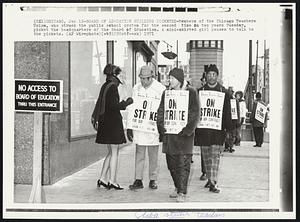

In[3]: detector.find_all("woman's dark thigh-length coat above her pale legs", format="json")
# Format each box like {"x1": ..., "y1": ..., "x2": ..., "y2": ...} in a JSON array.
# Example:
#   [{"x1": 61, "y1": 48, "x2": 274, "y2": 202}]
[{"x1": 93, "y1": 77, "x2": 126, "y2": 144}]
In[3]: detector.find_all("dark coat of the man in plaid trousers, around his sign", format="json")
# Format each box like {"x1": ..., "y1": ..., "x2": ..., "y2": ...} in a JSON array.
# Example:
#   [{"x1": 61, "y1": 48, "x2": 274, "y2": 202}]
[{"x1": 195, "y1": 83, "x2": 233, "y2": 146}]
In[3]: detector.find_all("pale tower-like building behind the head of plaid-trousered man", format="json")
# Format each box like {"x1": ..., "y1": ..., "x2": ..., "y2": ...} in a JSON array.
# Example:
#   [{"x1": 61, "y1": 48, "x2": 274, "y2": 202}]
[{"x1": 187, "y1": 40, "x2": 223, "y2": 88}]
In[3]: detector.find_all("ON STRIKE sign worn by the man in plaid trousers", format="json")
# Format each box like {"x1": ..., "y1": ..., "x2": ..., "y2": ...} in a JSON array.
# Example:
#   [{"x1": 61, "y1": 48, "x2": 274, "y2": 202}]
[{"x1": 197, "y1": 90, "x2": 225, "y2": 130}]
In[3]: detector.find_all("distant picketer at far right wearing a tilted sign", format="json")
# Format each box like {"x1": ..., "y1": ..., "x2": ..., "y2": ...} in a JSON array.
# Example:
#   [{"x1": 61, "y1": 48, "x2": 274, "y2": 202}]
[{"x1": 250, "y1": 92, "x2": 268, "y2": 147}]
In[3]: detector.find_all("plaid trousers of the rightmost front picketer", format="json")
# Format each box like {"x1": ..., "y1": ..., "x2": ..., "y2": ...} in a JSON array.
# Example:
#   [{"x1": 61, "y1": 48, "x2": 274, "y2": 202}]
[{"x1": 201, "y1": 145, "x2": 222, "y2": 182}]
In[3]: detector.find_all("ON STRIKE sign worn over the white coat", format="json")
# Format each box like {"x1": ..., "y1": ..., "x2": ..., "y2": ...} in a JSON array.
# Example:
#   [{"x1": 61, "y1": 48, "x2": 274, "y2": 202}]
[{"x1": 127, "y1": 95, "x2": 160, "y2": 133}]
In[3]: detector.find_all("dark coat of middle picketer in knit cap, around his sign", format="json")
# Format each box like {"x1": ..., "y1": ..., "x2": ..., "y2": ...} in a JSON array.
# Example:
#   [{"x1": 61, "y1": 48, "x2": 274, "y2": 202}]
[{"x1": 157, "y1": 82, "x2": 199, "y2": 155}]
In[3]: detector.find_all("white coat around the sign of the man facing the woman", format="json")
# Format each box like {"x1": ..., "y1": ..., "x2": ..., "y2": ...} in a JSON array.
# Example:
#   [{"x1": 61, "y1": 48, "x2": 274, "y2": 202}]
[{"x1": 128, "y1": 79, "x2": 166, "y2": 146}]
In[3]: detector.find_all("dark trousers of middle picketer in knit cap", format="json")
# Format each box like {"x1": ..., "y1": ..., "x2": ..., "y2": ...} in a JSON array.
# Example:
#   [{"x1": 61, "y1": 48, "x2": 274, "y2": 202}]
[{"x1": 166, "y1": 154, "x2": 193, "y2": 194}]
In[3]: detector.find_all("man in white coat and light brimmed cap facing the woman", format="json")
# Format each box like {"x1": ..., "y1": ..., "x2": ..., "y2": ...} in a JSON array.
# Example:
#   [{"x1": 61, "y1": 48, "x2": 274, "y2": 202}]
[{"x1": 127, "y1": 66, "x2": 166, "y2": 190}]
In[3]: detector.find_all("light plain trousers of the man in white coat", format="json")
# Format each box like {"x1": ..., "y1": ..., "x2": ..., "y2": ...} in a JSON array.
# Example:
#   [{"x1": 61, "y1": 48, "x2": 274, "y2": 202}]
[{"x1": 135, "y1": 145, "x2": 159, "y2": 180}]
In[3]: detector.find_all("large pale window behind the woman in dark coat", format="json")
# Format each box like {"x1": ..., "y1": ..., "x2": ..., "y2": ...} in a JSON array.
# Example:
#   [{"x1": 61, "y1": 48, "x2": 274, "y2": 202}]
[{"x1": 70, "y1": 41, "x2": 107, "y2": 138}]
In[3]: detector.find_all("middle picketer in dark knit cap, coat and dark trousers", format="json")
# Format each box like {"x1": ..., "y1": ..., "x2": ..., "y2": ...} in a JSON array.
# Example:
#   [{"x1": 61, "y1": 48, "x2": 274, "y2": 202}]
[{"x1": 157, "y1": 68, "x2": 199, "y2": 202}]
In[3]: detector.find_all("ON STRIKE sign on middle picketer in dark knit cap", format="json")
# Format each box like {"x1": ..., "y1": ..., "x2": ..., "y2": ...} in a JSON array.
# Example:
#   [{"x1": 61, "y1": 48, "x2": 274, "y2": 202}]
[{"x1": 164, "y1": 90, "x2": 189, "y2": 134}]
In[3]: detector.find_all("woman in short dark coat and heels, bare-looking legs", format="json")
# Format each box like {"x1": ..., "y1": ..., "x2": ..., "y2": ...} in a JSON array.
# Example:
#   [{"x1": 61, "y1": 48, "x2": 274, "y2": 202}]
[{"x1": 92, "y1": 64, "x2": 133, "y2": 190}]
